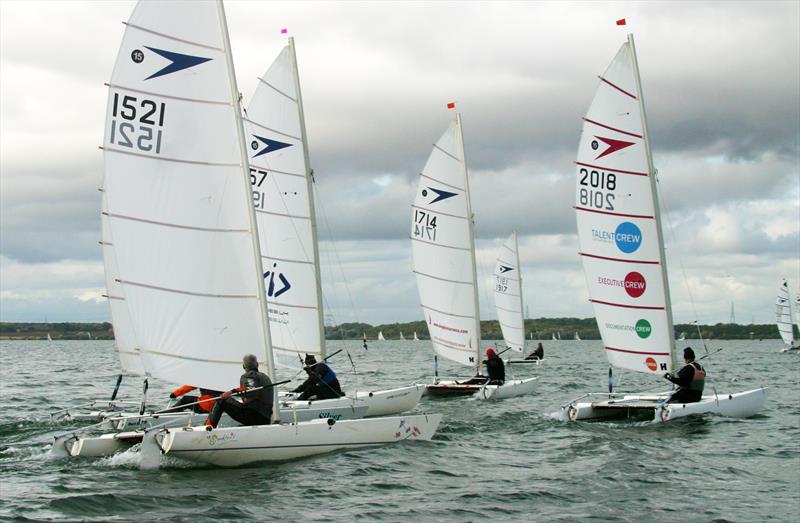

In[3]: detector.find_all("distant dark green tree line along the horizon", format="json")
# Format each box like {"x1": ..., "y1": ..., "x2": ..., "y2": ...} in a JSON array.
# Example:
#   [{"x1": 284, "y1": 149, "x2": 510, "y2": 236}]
[{"x1": 0, "y1": 318, "x2": 798, "y2": 340}]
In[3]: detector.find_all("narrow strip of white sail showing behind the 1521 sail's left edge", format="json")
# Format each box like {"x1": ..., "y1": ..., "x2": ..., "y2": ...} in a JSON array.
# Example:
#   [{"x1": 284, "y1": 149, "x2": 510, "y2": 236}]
[{"x1": 100, "y1": 191, "x2": 145, "y2": 375}]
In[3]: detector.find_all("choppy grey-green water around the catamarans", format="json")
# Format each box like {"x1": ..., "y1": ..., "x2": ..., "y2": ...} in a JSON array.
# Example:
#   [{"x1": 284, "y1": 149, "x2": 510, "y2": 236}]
[{"x1": 0, "y1": 341, "x2": 800, "y2": 522}]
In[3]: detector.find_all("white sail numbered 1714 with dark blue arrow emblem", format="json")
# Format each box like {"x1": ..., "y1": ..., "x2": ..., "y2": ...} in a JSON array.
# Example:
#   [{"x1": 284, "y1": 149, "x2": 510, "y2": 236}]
[{"x1": 411, "y1": 116, "x2": 480, "y2": 368}]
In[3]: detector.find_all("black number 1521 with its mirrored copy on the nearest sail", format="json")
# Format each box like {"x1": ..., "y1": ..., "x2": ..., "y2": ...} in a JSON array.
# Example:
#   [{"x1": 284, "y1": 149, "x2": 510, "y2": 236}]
[{"x1": 109, "y1": 93, "x2": 166, "y2": 154}]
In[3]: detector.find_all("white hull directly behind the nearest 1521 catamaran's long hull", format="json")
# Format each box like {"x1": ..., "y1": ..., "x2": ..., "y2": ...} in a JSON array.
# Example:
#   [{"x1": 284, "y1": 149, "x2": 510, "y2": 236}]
[{"x1": 281, "y1": 385, "x2": 425, "y2": 419}]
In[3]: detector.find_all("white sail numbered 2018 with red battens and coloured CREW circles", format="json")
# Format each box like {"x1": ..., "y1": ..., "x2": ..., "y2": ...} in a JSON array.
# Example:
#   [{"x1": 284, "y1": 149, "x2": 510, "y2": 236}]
[{"x1": 575, "y1": 36, "x2": 674, "y2": 374}]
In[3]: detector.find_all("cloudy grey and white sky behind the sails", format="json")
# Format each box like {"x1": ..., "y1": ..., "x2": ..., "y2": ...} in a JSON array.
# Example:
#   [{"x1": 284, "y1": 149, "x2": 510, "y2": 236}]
[{"x1": 0, "y1": 0, "x2": 800, "y2": 324}]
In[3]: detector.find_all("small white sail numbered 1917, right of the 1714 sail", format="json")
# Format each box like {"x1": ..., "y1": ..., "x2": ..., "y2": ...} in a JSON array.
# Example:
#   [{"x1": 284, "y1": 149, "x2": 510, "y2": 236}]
[{"x1": 494, "y1": 232, "x2": 525, "y2": 352}]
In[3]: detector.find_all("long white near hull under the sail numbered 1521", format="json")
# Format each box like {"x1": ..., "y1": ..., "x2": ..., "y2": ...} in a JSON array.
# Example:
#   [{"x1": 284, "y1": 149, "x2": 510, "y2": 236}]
[{"x1": 156, "y1": 414, "x2": 442, "y2": 467}]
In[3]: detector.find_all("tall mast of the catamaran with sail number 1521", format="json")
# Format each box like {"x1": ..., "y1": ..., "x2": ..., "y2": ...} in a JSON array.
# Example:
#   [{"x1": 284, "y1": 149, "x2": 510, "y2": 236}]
[{"x1": 217, "y1": 0, "x2": 281, "y2": 423}]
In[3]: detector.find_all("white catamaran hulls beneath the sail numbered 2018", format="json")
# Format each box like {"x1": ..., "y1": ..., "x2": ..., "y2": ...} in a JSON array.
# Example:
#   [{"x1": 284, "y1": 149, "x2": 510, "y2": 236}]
[{"x1": 561, "y1": 387, "x2": 767, "y2": 423}]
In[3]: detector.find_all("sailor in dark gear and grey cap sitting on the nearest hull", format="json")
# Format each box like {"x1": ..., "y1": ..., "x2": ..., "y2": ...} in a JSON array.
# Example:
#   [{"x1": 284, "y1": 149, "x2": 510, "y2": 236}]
[{"x1": 206, "y1": 354, "x2": 275, "y2": 430}]
